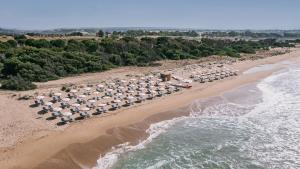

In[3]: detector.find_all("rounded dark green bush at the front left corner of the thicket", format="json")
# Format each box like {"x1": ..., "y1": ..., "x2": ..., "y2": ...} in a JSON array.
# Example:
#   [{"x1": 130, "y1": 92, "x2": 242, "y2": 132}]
[{"x1": 1, "y1": 75, "x2": 36, "y2": 91}]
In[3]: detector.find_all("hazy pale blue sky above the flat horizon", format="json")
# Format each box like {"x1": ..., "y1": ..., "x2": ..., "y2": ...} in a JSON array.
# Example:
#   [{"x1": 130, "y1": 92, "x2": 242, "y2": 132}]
[{"x1": 0, "y1": 0, "x2": 300, "y2": 30}]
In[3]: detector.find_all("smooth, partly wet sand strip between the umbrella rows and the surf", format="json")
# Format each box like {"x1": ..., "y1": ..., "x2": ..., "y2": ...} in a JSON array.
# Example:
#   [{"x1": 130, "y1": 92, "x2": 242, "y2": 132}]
[{"x1": 0, "y1": 48, "x2": 300, "y2": 168}]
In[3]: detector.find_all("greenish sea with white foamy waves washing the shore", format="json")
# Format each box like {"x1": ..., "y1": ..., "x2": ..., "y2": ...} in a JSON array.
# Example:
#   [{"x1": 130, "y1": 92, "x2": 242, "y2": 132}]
[{"x1": 95, "y1": 64, "x2": 300, "y2": 169}]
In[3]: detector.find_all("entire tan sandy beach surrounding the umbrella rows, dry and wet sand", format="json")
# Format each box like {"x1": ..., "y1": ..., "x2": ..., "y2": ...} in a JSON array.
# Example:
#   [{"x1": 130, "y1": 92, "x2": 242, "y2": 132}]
[{"x1": 0, "y1": 47, "x2": 300, "y2": 169}]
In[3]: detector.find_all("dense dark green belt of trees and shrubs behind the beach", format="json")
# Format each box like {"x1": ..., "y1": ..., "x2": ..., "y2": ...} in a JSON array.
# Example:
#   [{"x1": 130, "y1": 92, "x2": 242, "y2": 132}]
[{"x1": 0, "y1": 36, "x2": 293, "y2": 90}]
